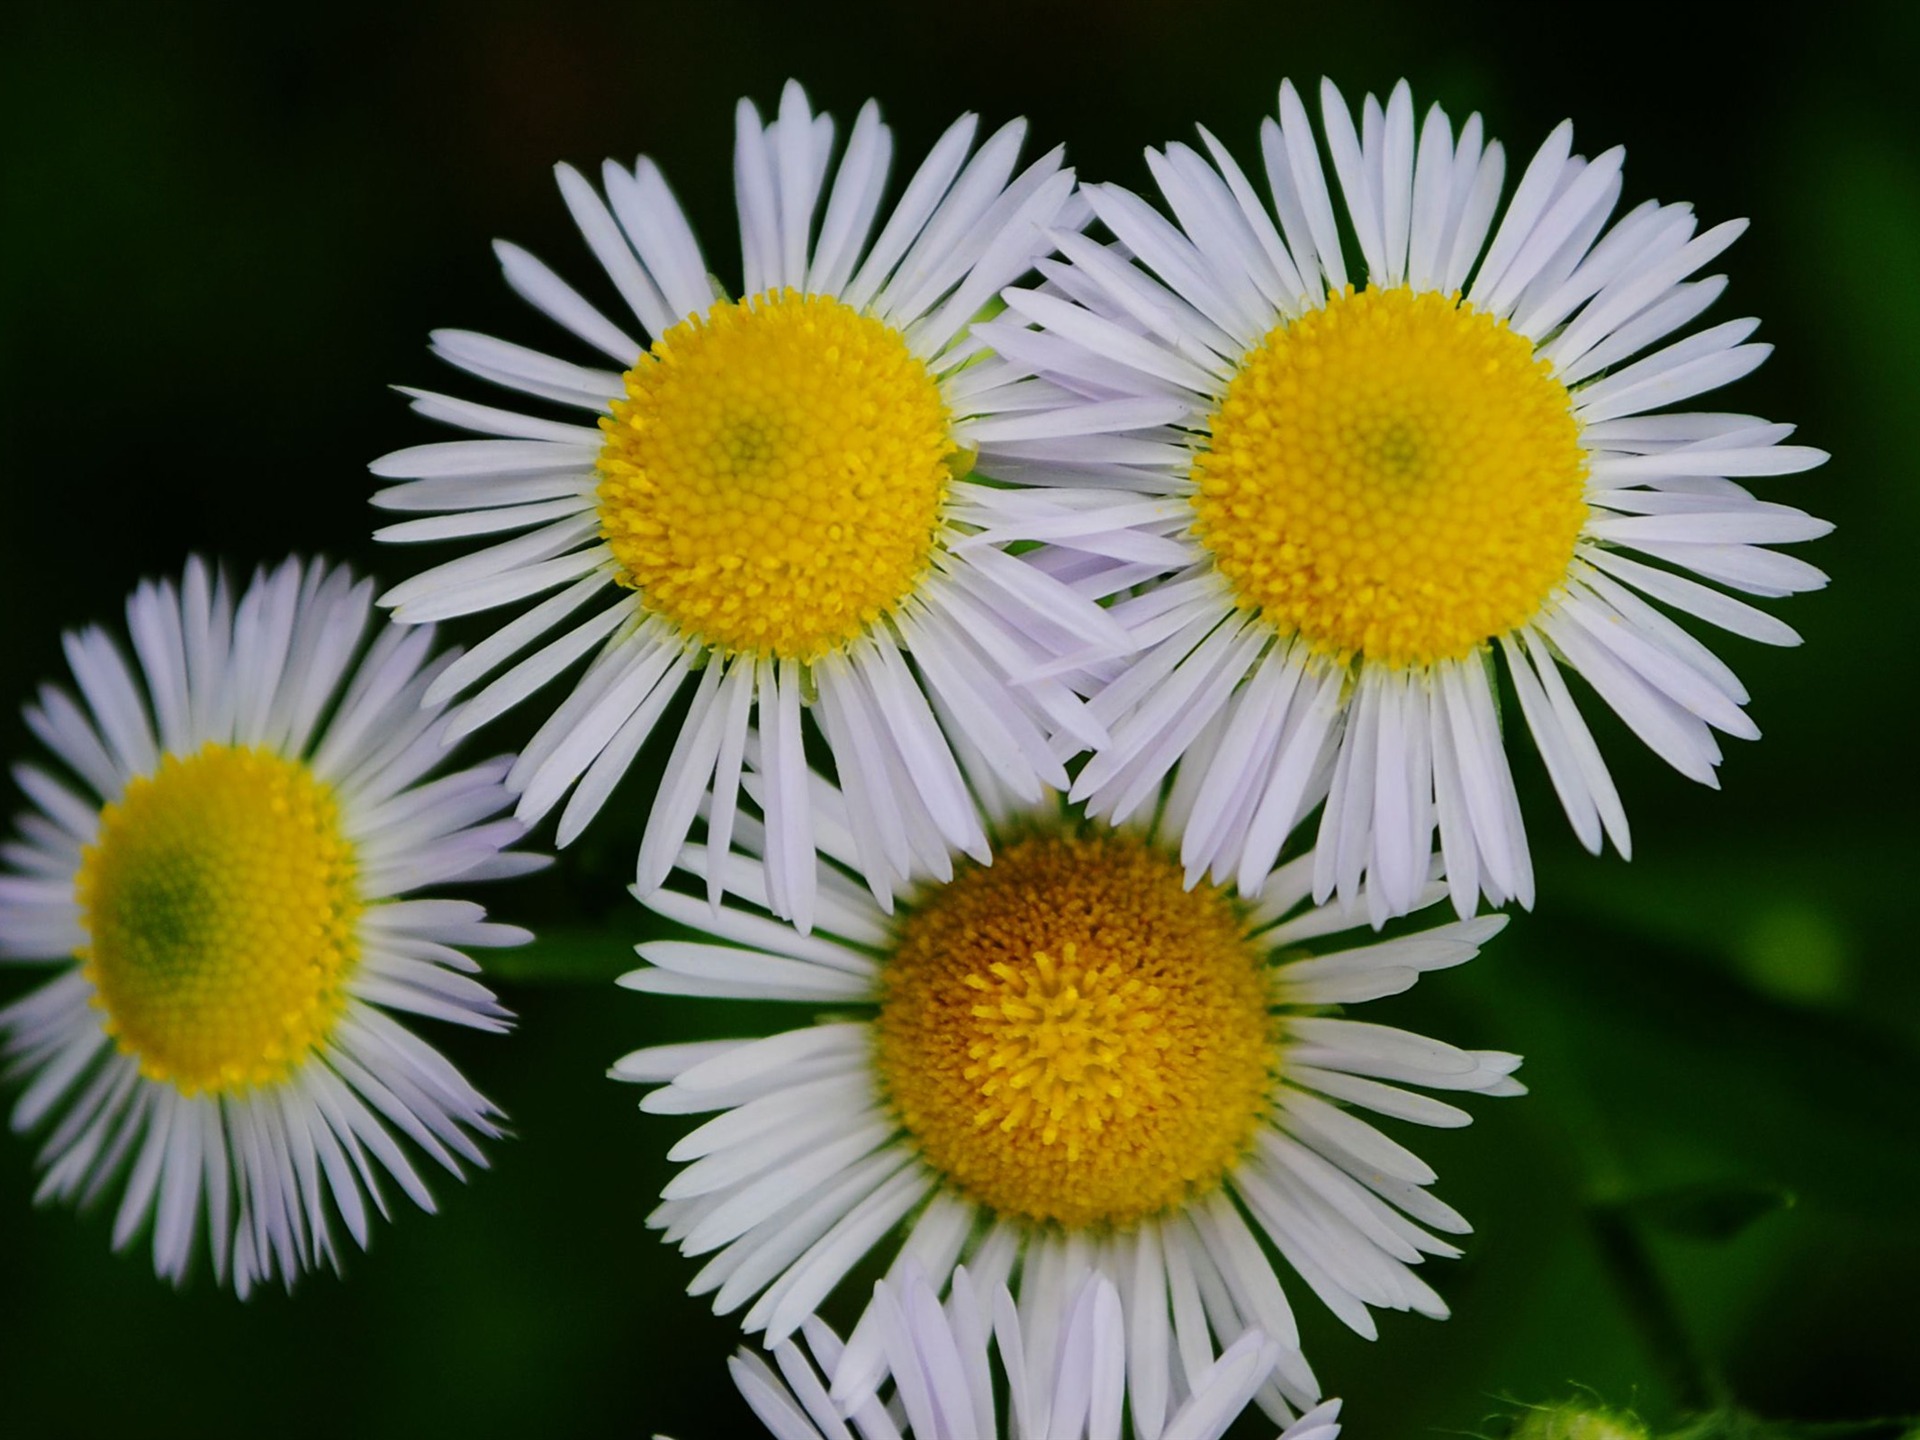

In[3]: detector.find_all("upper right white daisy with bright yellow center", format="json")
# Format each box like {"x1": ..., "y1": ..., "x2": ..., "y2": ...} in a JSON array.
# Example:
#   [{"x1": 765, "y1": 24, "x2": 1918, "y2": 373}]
[{"x1": 981, "y1": 83, "x2": 1830, "y2": 920}]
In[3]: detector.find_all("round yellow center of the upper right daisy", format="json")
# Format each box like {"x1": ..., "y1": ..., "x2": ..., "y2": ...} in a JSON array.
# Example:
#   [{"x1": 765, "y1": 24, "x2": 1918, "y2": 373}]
[{"x1": 1194, "y1": 288, "x2": 1586, "y2": 666}]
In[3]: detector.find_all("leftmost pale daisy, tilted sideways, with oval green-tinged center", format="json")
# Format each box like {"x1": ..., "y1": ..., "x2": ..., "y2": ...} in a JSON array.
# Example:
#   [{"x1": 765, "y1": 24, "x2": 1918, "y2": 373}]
[{"x1": 0, "y1": 559, "x2": 541, "y2": 1296}]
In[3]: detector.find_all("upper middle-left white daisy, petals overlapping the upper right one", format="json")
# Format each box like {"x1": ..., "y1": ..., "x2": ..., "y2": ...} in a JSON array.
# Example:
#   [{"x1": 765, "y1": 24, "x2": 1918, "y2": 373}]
[{"x1": 372, "y1": 84, "x2": 1128, "y2": 929}]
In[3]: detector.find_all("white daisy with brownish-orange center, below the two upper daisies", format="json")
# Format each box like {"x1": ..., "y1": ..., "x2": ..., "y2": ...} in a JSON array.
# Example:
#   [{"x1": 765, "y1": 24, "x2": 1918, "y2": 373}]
[{"x1": 612, "y1": 780, "x2": 1521, "y2": 1434}]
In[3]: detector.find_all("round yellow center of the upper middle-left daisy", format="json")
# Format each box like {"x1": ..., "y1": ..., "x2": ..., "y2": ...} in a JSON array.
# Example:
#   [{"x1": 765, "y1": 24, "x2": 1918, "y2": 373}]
[{"x1": 599, "y1": 290, "x2": 966, "y2": 660}]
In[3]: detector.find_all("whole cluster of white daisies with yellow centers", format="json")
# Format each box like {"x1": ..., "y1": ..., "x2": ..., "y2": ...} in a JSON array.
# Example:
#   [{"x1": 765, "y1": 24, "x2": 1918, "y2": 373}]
[{"x1": 0, "y1": 83, "x2": 1828, "y2": 1440}]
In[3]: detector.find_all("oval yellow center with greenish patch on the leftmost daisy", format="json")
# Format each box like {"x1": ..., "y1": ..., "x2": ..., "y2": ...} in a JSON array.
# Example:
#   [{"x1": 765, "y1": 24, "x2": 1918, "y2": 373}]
[{"x1": 75, "y1": 743, "x2": 361, "y2": 1094}]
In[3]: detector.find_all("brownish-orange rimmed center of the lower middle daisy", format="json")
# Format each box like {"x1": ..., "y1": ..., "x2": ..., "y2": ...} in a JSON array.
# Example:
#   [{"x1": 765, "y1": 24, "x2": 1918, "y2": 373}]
[{"x1": 877, "y1": 831, "x2": 1277, "y2": 1227}]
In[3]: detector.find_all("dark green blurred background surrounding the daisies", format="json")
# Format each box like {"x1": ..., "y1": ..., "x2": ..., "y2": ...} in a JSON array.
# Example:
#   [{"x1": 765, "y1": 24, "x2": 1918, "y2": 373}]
[{"x1": 0, "y1": 0, "x2": 1920, "y2": 1440}]
